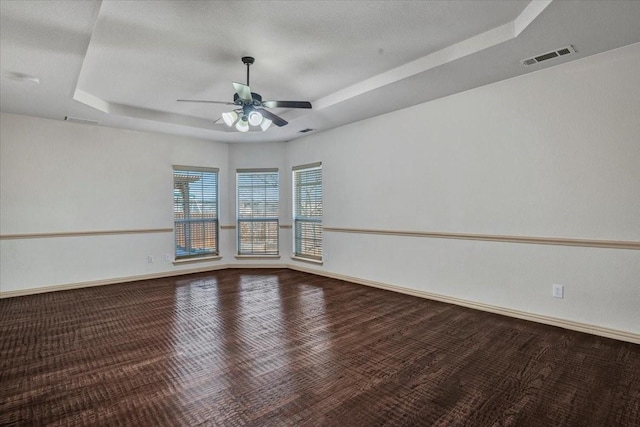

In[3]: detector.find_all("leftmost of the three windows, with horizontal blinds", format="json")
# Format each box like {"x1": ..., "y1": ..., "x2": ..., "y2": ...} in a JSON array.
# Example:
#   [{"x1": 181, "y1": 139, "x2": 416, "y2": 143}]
[{"x1": 173, "y1": 166, "x2": 218, "y2": 259}]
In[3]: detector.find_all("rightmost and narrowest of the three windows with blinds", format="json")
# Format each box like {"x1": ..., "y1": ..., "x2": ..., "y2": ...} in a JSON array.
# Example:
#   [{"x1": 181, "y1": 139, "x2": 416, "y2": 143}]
[{"x1": 293, "y1": 163, "x2": 322, "y2": 260}]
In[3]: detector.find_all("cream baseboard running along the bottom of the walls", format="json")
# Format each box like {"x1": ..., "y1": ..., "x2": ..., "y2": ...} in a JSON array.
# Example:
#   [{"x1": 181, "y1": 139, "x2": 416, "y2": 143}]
[{"x1": 0, "y1": 264, "x2": 640, "y2": 344}]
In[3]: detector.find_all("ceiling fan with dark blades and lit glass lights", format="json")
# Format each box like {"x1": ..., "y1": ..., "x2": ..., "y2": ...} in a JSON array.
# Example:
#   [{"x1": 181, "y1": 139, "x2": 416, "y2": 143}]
[{"x1": 178, "y1": 56, "x2": 311, "y2": 132}]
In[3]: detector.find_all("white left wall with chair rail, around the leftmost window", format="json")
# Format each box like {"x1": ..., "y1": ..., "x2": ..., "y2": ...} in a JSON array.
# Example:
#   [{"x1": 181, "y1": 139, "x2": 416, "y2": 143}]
[{"x1": 0, "y1": 114, "x2": 233, "y2": 292}]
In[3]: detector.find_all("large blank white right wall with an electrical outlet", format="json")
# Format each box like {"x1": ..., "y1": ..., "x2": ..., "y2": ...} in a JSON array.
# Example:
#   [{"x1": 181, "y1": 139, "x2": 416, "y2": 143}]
[{"x1": 289, "y1": 45, "x2": 640, "y2": 333}]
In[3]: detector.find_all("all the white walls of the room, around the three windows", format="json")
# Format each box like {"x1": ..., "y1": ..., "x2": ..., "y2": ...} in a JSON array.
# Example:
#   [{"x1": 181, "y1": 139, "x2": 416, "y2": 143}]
[{"x1": 0, "y1": 45, "x2": 640, "y2": 334}]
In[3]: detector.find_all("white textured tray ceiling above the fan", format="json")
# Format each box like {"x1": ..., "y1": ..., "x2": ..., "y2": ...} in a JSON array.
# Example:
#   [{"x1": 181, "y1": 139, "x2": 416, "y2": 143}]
[{"x1": 0, "y1": 0, "x2": 640, "y2": 142}]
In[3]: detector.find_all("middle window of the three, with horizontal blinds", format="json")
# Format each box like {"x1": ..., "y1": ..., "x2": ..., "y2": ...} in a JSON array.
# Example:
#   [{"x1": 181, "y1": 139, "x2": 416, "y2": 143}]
[{"x1": 236, "y1": 169, "x2": 279, "y2": 255}]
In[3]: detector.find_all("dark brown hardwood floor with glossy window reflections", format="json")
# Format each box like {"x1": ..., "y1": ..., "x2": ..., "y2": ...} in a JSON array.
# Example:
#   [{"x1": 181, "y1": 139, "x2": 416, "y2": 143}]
[{"x1": 0, "y1": 270, "x2": 640, "y2": 426}]
